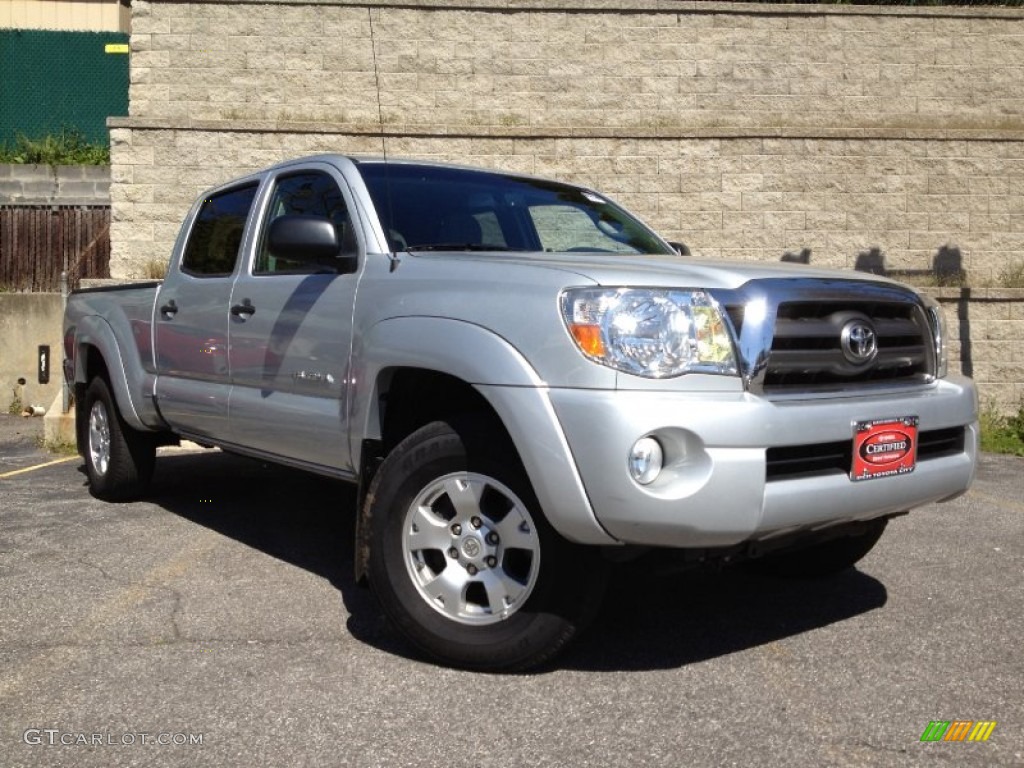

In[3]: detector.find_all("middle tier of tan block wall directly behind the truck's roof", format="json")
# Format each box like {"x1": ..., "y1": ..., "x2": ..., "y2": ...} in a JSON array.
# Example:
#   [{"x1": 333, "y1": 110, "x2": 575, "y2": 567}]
[{"x1": 111, "y1": 127, "x2": 1024, "y2": 285}]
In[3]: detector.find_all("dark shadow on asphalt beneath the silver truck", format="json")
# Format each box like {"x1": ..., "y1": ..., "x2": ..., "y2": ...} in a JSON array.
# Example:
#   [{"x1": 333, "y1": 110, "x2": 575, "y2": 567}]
[{"x1": 148, "y1": 452, "x2": 887, "y2": 671}]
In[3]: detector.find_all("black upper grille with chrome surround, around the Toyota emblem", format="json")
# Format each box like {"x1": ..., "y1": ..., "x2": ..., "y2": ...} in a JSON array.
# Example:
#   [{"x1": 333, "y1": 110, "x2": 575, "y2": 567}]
[{"x1": 763, "y1": 301, "x2": 932, "y2": 392}]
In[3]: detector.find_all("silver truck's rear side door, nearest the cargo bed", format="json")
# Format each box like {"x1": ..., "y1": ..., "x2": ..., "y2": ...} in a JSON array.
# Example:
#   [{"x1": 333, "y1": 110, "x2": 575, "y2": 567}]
[{"x1": 154, "y1": 179, "x2": 259, "y2": 440}]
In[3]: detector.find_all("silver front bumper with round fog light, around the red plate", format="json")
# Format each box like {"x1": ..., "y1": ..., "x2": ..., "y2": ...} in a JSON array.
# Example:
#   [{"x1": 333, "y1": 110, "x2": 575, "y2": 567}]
[{"x1": 549, "y1": 377, "x2": 978, "y2": 548}]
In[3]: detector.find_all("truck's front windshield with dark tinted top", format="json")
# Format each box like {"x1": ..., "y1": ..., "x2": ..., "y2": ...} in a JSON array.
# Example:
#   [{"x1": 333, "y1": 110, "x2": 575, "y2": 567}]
[{"x1": 358, "y1": 163, "x2": 675, "y2": 254}]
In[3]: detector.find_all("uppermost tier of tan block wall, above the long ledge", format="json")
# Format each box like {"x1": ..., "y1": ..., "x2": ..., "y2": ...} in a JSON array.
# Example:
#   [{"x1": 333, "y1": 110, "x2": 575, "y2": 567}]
[{"x1": 130, "y1": 0, "x2": 1024, "y2": 133}]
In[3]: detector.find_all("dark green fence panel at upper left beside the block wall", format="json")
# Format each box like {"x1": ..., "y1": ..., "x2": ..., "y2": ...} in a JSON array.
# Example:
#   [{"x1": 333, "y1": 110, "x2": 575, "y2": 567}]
[{"x1": 0, "y1": 30, "x2": 128, "y2": 144}]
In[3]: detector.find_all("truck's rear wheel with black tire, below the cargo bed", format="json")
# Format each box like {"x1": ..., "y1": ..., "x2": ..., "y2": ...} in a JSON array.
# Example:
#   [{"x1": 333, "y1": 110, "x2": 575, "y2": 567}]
[{"x1": 81, "y1": 377, "x2": 157, "y2": 501}]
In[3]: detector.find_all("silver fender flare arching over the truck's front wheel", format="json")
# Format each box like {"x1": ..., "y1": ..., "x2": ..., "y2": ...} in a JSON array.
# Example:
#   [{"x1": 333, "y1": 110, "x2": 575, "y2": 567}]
[{"x1": 350, "y1": 317, "x2": 617, "y2": 581}]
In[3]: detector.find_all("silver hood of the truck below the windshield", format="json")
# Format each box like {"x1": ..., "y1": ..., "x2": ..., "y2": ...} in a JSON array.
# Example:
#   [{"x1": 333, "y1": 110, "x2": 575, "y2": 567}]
[{"x1": 407, "y1": 252, "x2": 905, "y2": 289}]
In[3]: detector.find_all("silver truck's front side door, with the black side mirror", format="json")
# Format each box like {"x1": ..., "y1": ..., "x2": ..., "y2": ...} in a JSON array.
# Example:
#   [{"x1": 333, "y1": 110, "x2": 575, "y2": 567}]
[{"x1": 228, "y1": 163, "x2": 361, "y2": 474}]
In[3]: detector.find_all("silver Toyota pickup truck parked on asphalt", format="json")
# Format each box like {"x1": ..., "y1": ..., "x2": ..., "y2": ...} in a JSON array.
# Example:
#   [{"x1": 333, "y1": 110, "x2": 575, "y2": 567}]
[{"x1": 65, "y1": 155, "x2": 978, "y2": 670}]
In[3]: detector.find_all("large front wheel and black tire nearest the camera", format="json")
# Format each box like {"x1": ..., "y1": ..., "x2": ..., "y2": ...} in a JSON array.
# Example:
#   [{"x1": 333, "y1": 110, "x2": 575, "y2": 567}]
[{"x1": 366, "y1": 422, "x2": 607, "y2": 672}]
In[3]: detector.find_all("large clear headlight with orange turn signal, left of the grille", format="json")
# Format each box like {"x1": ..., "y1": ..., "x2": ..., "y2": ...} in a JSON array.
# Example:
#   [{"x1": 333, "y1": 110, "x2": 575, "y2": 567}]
[{"x1": 561, "y1": 288, "x2": 736, "y2": 379}]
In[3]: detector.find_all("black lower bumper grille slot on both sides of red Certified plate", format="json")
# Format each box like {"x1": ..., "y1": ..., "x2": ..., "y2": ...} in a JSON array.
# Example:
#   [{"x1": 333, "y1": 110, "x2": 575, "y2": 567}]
[{"x1": 765, "y1": 427, "x2": 965, "y2": 481}]
